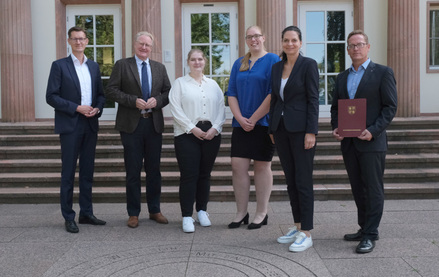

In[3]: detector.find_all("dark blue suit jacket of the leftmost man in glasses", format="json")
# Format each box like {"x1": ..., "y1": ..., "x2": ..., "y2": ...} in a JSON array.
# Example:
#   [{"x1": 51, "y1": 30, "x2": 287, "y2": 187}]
[{"x1": 46, "y1": 56, "x2": 105, "y2": 134}]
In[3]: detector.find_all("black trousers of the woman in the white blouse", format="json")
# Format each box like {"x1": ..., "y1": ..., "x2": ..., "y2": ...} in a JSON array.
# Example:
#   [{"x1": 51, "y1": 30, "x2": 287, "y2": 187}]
[{"x1": 174, "y1": 122, "x2": 221, "y2": 217}]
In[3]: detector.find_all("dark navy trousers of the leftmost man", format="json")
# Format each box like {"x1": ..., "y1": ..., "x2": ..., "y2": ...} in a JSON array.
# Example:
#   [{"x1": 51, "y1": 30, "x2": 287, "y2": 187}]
[{"x1": 59, "y1": 116, "x2": 98, "y2": 220}]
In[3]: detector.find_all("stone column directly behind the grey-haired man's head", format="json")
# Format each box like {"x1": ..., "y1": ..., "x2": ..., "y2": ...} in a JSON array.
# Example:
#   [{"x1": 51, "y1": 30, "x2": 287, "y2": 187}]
[{"x1": 131, "y1": 0, "x2": 162, "y2": 62}]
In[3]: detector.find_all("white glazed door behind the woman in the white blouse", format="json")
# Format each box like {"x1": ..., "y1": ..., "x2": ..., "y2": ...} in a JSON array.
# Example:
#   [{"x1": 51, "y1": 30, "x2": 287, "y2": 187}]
[{"x1": 182, "y1": 3, "x2": 238, "y2": 118}]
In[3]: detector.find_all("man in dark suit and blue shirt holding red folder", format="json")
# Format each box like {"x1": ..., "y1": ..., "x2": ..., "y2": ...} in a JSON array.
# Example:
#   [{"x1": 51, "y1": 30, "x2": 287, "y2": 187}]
[{"x1": 331, "y1": 30, "x2": 397, "y2": 253}]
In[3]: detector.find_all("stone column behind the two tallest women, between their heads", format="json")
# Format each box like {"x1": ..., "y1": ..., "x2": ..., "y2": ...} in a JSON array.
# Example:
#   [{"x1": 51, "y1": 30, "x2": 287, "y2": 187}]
[{"x1": 256, "y1": 0, "x2": 286, "y2": 55}]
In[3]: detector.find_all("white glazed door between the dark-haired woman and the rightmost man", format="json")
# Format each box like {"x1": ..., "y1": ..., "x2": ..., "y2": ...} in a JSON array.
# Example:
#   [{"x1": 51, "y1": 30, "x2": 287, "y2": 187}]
[{"x1": 298, "y1": 1, "x2": 354, "y2": 117}]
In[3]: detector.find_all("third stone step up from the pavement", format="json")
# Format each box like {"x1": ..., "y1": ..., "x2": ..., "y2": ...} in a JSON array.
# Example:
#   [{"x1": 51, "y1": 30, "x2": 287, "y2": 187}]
[{"x1": 0, "y1": 153, "x2": 439, "y2": 173}]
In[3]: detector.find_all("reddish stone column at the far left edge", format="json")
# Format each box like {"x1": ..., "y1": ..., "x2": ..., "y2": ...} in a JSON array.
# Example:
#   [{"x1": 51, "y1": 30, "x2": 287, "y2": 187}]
[{"x1": 0, "y1": 0, "x2": 35, "y2": 122}]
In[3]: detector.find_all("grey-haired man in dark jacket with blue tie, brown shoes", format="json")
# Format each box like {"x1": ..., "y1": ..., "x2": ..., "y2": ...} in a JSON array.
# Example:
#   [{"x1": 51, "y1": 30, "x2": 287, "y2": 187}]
[{"x1": 105, "y1": 32, "x2": 171, "y2": 228}]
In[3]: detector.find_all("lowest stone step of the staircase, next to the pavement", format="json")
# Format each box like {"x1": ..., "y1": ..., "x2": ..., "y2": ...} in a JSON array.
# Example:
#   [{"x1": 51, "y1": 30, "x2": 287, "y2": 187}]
[{"x1": 0, "y1": 182, "x2": 439, "y2": 204}]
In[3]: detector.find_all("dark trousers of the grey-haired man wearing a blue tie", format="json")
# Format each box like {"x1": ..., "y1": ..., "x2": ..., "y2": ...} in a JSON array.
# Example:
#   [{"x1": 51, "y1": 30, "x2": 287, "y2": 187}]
[{"x1": 120, "y1": 118, "x2": 162, "y2": 216}]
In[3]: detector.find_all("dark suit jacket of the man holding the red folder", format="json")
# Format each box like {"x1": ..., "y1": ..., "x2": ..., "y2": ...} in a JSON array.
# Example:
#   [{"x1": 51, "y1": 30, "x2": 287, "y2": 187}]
[{"x1": 331, "y1": 62, "x2": 397, "y2": 152}]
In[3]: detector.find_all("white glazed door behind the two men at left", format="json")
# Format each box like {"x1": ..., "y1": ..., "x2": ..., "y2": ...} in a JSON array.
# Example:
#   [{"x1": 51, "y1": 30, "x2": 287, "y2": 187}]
[{"x1": 66, "y1": 5, "x2": 122, "y2": 120}]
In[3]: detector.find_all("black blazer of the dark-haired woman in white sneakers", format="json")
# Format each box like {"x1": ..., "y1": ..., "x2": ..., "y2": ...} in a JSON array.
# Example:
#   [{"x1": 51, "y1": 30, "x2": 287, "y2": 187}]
[{"x1": 269, "y1": 55, "x2": 319, "y2": 134}]
